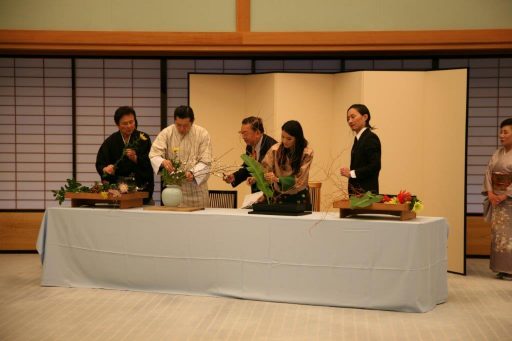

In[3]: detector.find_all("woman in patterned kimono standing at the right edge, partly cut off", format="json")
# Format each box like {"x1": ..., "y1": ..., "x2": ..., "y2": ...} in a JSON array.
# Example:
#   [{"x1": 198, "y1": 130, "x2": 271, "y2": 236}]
[{"x1": 482, "y1": 118, "x2": 512, "y2": 280}]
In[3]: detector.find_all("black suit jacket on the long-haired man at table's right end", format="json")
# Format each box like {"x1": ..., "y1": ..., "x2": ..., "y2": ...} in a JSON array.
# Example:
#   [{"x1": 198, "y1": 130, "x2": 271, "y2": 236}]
[{"x1": 348, "y1": 128, "x2": 381, "y2": 194}]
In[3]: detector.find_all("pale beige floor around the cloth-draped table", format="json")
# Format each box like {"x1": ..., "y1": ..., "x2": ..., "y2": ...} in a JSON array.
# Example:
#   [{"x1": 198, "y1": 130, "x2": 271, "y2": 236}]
[{"x1": 0, "y1": 254, "x2": 512, "y2": 340}]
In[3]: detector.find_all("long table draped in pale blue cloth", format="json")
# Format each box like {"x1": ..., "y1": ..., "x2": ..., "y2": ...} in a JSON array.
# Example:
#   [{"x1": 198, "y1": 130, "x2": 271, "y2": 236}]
[{"x1": 38, "y1": 207, "x2": 448, "y2": 312}]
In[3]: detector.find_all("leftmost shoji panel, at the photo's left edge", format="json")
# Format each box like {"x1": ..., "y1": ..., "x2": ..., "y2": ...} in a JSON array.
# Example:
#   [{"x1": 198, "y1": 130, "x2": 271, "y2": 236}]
[{"x1": 0, "y1": 58, "x2": 73, "y2": 210}]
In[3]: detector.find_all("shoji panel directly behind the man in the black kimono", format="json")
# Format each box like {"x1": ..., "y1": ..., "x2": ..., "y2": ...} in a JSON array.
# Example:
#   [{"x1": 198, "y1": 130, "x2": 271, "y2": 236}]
[{"x1": 76, "y1": 58, "x2": 160, "y2": 200}]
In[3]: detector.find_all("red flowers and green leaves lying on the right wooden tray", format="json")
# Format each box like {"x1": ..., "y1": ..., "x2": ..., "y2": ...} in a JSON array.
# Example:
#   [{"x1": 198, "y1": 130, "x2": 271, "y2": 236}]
[{"x1": 349, "y1": 190, "x2": 423, "y2": 213}]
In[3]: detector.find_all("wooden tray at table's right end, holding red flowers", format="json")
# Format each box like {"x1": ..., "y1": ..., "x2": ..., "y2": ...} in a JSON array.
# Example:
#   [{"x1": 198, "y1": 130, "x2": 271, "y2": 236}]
[{"x1": 332, "y1": 199, "x2": 416, "y2": 220}]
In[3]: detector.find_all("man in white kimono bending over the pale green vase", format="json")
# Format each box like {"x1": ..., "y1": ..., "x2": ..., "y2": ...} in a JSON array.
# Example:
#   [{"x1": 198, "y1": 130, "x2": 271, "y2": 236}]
[{"x1": 149, "y1": 105, "x2": 212, "y2": 207}]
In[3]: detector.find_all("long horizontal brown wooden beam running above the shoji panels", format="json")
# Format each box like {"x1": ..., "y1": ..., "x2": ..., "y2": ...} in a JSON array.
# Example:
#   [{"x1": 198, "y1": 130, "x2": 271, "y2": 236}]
[{"x1": 0, "y1": 29, "x2": 512, "y2": 55}]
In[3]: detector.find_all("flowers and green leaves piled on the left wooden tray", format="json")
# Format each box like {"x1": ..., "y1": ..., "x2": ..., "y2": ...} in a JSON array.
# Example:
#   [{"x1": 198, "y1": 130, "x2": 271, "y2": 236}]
[{"x1": 52, "y1": 179, "x2": 137, "y2": 205}]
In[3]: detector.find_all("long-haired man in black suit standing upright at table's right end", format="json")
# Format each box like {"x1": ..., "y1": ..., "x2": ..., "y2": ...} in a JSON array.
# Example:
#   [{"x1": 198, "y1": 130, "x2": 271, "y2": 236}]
[{"x1": 340, "y1": 104, "x2": 381, "y2": 194}]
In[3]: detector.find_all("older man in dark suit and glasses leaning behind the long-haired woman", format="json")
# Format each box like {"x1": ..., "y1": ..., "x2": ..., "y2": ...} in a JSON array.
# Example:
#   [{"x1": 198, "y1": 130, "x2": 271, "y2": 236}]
[{"x1": 224, "y1": 116, "x2": 277, "y2": 193}]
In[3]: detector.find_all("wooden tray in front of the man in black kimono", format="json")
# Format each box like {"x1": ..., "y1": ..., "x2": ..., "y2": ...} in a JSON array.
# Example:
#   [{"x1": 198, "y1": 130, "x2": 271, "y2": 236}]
[{"x1": 65, "y1": 192, "x2": 149, "y2": 208}]
